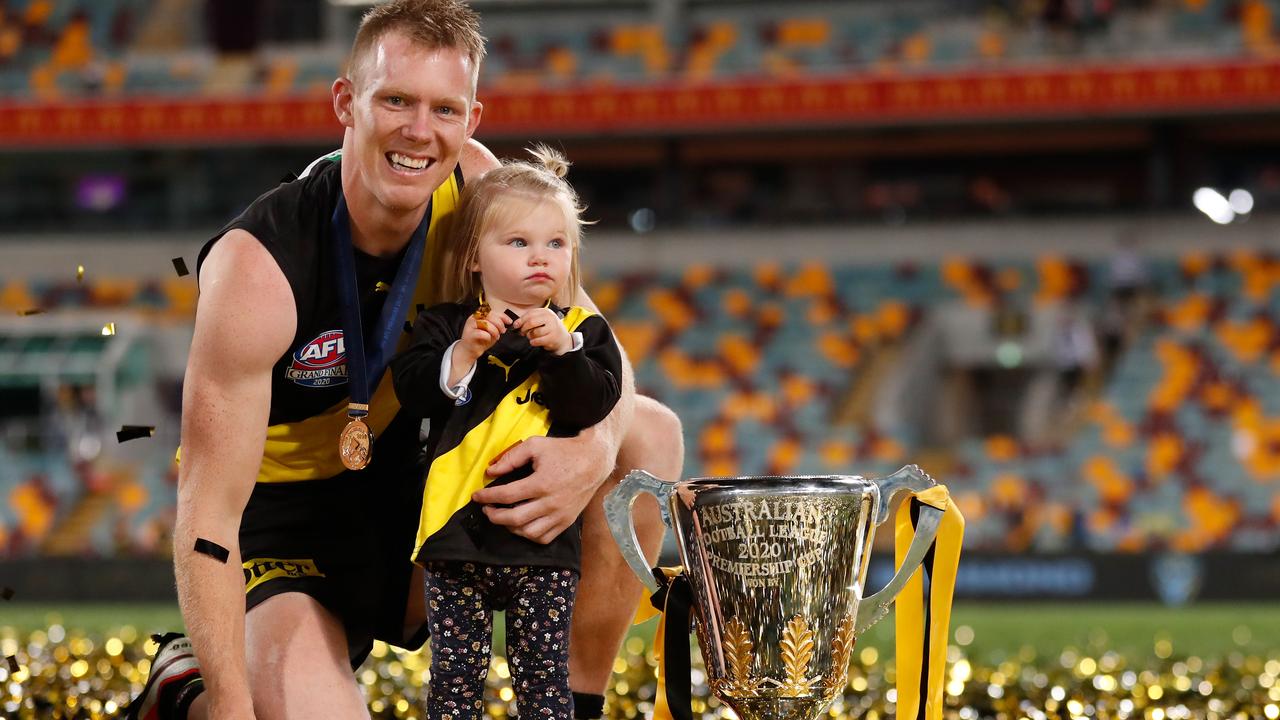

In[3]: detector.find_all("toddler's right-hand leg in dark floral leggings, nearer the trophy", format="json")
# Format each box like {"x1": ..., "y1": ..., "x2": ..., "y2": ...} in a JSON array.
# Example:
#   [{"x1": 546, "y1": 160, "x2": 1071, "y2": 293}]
[{"x1": 507, "y1": 568, "x2": 577, "y2": 720}]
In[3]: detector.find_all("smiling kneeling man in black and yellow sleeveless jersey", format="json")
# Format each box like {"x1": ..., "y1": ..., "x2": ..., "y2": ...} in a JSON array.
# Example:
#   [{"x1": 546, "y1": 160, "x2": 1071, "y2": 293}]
[{"x1": 127, "y1": 0, "x2": 681, "y2": 720}]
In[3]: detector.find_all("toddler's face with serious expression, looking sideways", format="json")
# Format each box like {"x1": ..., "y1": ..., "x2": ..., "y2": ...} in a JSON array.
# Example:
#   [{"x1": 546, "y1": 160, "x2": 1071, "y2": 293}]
[{"x1": 471, "y1": 195, "x2": 573, "y2": 307}]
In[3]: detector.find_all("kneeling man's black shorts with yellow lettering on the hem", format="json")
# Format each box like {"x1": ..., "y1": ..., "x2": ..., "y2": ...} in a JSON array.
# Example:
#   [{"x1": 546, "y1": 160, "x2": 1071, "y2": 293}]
[{"x1": 239, "y1": 450, "x2": 426, "y2": 667}]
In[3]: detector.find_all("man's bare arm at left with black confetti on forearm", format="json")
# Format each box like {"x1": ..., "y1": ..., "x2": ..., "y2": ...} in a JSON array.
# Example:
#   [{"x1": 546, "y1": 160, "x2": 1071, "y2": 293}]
[{"x1": 174, "y1": 231, "x2": 297, "y2": 719}]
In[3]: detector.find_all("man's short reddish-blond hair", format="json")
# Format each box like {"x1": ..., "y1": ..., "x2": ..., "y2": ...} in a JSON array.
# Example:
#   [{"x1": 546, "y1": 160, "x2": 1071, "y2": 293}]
[{"x1": 347, "y1": 0, "x2": 484, "y2": 87}]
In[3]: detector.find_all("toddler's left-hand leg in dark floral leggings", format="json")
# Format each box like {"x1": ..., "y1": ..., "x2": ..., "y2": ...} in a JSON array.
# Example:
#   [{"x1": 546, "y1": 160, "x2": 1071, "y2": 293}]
[{"x1": 426, "y1": 562, "x2": 493, "y2": 720}]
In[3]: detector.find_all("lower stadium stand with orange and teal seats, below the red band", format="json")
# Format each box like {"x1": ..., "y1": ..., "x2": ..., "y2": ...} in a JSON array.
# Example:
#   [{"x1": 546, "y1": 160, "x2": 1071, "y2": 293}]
[{"x1": 0, "y1": 238, "x2": 1280, "y2": 553}]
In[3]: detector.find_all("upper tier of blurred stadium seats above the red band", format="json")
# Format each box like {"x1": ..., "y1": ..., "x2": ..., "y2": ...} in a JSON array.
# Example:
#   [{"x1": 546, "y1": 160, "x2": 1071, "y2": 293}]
[{"x1": 0, "y1": 0, "x2": 1276, "y2": 99}]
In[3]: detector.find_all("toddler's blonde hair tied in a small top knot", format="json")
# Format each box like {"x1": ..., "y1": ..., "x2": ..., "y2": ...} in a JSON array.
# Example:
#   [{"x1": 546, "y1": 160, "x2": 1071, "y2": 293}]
[{"x1": 442, "y1": 145, "x2": 586, "y2": 306}]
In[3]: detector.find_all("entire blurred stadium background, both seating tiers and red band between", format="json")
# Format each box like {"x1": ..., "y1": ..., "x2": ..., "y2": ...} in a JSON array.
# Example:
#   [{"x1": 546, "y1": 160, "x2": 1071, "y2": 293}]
[{"x1": 0, "y1": 0, "x2": 1280, "y2": 557}]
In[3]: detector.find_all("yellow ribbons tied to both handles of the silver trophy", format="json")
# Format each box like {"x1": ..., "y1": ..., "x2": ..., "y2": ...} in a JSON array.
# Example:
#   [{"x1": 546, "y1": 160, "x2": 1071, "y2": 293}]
[{"x1": 635, "y1": 486, "x2": 964, "y2": 720}]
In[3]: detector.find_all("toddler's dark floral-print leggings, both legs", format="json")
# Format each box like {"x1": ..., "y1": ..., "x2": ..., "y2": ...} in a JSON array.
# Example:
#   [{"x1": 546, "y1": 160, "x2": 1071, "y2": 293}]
[{"x1": 426, "y1": 562, "x2": 577, "y2": 720}]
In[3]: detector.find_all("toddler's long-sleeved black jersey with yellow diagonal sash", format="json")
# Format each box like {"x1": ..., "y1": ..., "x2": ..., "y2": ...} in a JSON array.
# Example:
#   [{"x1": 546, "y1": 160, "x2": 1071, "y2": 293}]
[{"x1": 392, "y1": 297, "x2": 622, "y2": 570}]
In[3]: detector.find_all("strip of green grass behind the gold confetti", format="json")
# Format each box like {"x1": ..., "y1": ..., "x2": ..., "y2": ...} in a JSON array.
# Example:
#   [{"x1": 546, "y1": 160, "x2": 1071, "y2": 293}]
[{"x1": 0, "y1": 603, "x2": 1280, "y2": 661}]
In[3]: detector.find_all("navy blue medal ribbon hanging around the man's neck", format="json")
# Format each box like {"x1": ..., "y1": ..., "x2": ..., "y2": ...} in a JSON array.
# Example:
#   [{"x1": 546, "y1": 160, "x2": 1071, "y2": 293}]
[{"x1": 333, "y1": 193, "x2": 431, "y2": 418}]
